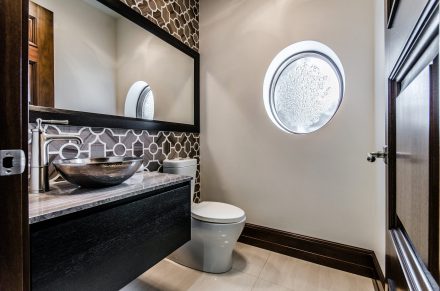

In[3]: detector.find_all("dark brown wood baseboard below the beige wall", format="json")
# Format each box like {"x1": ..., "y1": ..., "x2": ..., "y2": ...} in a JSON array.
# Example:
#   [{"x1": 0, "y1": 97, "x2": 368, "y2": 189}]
[{"x1": 238, "y1": 223, "x2": 385, "y2": 290}]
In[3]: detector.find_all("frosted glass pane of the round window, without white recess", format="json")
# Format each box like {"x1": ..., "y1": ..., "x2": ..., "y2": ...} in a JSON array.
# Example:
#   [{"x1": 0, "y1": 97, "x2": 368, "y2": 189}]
[{"x1": 271, "y1": 54, "x2": 342, "y2": 133}]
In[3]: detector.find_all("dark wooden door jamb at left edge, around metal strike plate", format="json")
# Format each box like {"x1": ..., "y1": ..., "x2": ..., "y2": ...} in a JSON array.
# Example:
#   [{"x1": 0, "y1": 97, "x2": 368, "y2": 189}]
[{"x1": 0, "y1": 0, "x2": 29, "y2": 291}]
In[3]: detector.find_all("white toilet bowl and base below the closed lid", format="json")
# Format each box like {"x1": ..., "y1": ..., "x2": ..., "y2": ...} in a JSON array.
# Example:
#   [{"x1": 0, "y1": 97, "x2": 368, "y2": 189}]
[{"x1": 169, "y1": 218, "x2": 246, "y2": 274}]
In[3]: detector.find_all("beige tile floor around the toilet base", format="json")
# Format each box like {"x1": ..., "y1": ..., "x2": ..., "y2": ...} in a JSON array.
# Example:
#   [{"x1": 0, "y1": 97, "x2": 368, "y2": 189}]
[{"x1": 121, "y1": 243, "x2": 374, "y2": 291}]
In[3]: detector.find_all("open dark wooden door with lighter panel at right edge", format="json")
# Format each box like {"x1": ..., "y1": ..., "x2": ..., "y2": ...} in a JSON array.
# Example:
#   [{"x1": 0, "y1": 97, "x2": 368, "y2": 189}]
[{"x1": 386, "y1": 0, "x2": 440, "y2": 290}]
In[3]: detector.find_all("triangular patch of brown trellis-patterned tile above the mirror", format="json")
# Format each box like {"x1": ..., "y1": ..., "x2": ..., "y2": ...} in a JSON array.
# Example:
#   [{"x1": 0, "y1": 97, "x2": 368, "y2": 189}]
[{"x1": 121, "y1": 0, "x2": 199, "y2": 51}]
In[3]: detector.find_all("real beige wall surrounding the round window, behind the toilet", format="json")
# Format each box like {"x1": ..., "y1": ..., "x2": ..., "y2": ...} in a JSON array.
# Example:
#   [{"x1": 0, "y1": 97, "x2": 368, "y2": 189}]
[{"x1": 200, "y1": 0, "x2": 379, "y2": 250}]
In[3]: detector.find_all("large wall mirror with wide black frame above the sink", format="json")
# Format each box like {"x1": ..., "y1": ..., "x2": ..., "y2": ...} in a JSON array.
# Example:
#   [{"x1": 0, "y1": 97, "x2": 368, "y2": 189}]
[{"x1": 29, "y1": 0, "x2": 199, "y2": 131}]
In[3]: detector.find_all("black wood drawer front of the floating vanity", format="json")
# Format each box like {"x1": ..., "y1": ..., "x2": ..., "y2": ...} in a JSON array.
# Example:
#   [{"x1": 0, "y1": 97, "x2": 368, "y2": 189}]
[{"x1": 31, "y1": 185, "x2": 191, "y2": 290}]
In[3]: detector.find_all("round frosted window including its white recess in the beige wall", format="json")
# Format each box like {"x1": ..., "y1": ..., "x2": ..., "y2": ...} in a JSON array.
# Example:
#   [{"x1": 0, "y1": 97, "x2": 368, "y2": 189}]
[{"x1": 263, "y1": 41, "x2": 345, "y2": 134}]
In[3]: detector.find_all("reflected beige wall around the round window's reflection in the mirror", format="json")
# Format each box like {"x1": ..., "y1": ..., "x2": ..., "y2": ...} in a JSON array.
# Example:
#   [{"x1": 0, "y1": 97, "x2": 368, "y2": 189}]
[{"x1": 116, "y1": 18, "x2": 194, "y2": 124}]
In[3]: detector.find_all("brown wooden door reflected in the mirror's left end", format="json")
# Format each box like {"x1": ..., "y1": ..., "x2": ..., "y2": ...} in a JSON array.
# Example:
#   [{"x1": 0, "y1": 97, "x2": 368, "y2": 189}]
[{"x1": 28, "y1": 2, "x2": 54, "y2": 107}]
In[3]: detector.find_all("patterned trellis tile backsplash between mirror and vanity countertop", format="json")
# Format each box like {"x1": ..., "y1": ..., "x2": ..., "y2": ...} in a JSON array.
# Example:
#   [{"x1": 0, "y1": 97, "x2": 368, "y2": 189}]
[{"x1": 31, "y1": 125, "x2": 200, "y2": 202}]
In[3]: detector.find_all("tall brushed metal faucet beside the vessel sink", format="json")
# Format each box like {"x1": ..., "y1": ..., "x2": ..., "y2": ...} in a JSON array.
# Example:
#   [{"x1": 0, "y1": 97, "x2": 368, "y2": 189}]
[{"x1": 30, "y1": 118, "x2": 83, "y2": 193}]
